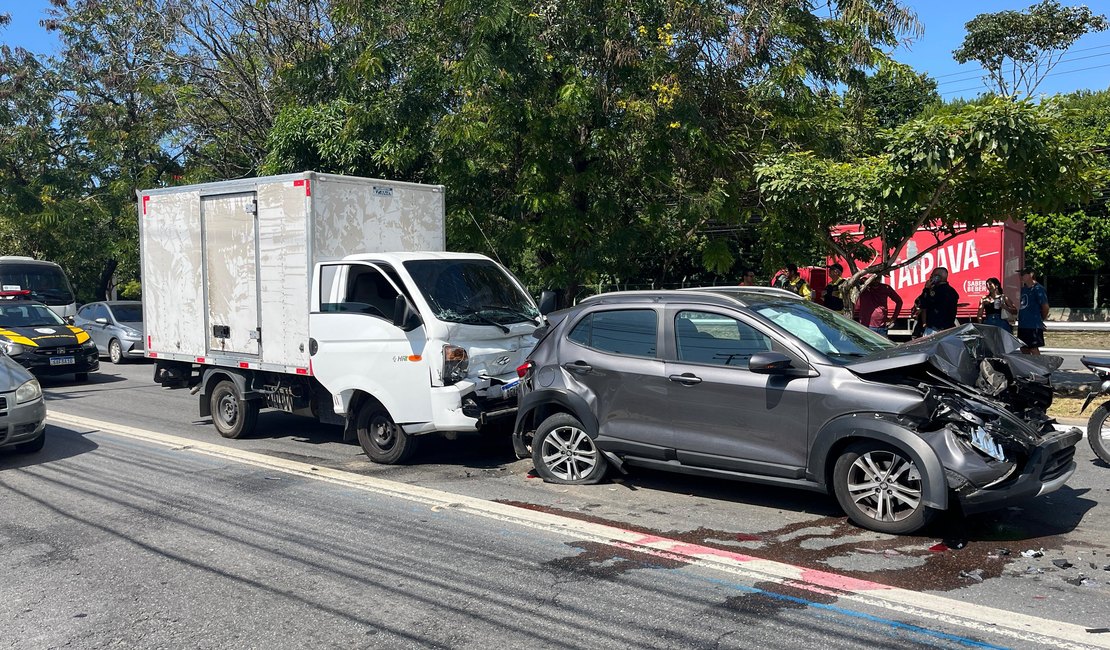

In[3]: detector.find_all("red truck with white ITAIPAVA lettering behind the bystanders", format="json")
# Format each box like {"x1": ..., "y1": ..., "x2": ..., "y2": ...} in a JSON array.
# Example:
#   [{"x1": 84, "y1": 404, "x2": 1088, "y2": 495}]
[{"x1": 827, "y1": 221, "x2": 1026, "y2": 337}]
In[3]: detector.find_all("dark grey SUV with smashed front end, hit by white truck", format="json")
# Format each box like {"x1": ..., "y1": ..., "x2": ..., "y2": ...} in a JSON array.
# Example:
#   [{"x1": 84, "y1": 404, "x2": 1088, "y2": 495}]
[{"x1": 513, "y1": 287, "x2": 1082, "y2": 534}]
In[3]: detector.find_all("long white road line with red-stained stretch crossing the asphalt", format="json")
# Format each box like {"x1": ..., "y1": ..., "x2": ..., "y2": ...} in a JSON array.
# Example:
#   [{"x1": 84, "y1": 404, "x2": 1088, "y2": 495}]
[{"x1": 49, "y1": 413, "x2": 1110, "y2": 648}]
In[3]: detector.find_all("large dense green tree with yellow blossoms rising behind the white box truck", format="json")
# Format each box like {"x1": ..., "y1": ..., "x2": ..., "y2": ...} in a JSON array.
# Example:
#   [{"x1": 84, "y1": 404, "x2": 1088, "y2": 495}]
[{"x1": 266, "y1": 0, "x2": 917, "y2": 292}]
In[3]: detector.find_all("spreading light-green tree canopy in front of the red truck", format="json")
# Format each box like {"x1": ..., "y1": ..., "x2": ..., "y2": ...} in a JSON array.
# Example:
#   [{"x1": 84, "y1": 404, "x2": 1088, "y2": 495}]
[{"x1": 757, "y1": 98, "x2": 1106, "y2": 295}]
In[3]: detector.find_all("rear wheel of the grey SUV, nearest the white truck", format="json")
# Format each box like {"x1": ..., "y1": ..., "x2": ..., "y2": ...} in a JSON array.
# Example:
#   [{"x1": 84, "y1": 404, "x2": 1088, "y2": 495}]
[{"x1": 532, "y1": 413, "x2": 608, "y2": 485}]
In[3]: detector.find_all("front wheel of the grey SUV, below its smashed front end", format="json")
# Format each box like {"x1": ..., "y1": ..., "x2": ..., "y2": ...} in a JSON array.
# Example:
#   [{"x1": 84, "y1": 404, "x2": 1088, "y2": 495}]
[{"x1": 833, "y1": 441, "x2": 935, "y2": 535}]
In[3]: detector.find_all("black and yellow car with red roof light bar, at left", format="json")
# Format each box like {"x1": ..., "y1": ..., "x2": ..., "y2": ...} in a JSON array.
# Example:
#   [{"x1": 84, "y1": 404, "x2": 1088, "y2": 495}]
[{"x1": 0, "y1": 292, "x2": 100, "y2": 382}]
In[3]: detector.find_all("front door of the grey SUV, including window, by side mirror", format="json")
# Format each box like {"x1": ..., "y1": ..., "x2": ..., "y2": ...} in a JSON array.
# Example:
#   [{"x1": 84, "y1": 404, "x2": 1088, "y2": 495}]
[{"x1": 664, "y1": 305, "x2": 809, "y2": 478}]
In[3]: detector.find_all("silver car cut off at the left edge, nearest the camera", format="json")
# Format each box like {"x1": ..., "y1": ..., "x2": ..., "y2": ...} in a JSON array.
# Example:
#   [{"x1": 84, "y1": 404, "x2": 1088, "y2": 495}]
[{"x1": 0, "y1": 353, "x2": 47, "y2": 453}]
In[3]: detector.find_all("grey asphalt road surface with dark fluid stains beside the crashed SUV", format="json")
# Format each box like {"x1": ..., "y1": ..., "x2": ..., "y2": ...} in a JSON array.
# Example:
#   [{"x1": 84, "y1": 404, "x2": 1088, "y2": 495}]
[{"x1": 0, "y1": 364, "x2": 1110, "y2": 648}]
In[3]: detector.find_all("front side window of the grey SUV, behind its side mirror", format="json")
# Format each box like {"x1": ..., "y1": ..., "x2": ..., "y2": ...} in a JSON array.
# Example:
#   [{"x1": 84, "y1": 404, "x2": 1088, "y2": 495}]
[{"x1": 675, "y1": 311, "x2": 771, "y2": 368}]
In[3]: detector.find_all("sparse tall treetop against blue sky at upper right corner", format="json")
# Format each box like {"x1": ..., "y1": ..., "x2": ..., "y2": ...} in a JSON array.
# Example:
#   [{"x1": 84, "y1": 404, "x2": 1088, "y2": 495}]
[{"x1": 952, "y1": 0, "x2": 1107, "y2": 97}]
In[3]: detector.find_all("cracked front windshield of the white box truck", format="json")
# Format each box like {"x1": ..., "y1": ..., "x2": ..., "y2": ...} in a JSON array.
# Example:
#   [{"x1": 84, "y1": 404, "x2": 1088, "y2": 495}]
[{"x1": 404, "y1": 260, "x2": 539, "y2": 326}]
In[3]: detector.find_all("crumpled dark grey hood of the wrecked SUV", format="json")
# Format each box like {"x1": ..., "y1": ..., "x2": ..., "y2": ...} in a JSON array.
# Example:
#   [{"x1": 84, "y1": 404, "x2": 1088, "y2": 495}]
[{"x1": 848, "y1": 323, "x2": 1063, "y2": 383}]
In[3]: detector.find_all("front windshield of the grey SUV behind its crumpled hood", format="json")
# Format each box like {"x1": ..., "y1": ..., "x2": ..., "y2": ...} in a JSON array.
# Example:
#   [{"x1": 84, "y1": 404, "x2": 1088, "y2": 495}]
[{"x1": 748, "y1": 299, "x2": 895, "y2": 364}]
